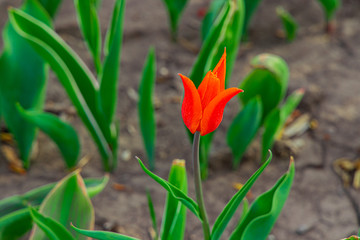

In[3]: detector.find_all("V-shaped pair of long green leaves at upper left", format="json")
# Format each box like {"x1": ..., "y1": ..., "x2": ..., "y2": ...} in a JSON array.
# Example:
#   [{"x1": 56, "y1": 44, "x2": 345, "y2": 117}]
[{"x1": 9, "y1": 0, "x2": 124, "y2": 171}]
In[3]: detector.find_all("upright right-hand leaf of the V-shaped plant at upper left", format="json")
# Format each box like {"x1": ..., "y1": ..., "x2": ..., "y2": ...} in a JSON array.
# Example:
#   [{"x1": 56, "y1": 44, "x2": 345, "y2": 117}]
[{"x1": 99, "y1": 0, "x2": 125, "y2": 124}]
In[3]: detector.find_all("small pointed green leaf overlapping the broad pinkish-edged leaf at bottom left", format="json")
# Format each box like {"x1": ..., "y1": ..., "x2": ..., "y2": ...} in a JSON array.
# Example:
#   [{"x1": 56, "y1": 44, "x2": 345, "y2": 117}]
[{"x1": 29, "y1": 207, "x2": 75, "y2": 240}]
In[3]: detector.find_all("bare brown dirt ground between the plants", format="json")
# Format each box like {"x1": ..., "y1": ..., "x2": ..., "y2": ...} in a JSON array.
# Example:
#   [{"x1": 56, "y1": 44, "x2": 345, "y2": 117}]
[{"x1": 0, "y1": 0, "x2": 360, "y2": 240}]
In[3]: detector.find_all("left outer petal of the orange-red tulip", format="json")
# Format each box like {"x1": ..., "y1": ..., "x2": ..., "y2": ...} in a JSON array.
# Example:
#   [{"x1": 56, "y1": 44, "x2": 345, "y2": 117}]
[{"x1": 179, "y1": 74, "x2": 202, "y2": 133}]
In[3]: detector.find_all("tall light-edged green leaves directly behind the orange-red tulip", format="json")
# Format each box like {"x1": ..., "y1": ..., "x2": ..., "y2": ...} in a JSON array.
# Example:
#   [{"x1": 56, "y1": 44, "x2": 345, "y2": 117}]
[{"x1": 189, "y1": 0, "x2": 244, "y2": 179}]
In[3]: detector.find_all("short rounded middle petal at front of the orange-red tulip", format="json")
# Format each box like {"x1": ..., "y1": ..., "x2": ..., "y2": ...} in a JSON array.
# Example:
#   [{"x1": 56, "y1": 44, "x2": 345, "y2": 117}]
[{"x1": 198, "y1": 71, "x2": 220, "y2": 109}]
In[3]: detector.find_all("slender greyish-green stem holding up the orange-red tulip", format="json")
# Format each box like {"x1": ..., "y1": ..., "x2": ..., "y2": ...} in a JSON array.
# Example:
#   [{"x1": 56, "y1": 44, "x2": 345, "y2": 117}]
[{"x1": 192, "y1": 131, "x2": 210, "y2": 240}]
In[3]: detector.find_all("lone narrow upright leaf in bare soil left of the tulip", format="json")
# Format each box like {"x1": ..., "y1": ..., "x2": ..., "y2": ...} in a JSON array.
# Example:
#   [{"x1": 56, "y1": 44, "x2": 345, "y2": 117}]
[{"x1": 138, "y1": 48, "x2": 156, "y2": 170}]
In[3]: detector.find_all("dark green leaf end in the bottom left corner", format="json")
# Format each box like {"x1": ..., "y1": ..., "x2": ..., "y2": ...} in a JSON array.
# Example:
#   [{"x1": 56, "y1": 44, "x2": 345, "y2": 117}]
[{"x1": 0, "y1": 208, "x2": 33, "y2": 240}]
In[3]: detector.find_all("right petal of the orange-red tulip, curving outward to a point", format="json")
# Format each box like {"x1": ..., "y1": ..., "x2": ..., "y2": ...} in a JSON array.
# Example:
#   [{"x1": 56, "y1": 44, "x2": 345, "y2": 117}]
[{"x1": 200, "y1": 88, "x2": 243, "y2": 136}]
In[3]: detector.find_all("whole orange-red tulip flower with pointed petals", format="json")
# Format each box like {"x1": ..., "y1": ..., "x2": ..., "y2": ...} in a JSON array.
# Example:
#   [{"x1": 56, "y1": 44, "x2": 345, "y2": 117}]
[{"x1": 179, "y1": 51, "x2": 243, "y2": 136}]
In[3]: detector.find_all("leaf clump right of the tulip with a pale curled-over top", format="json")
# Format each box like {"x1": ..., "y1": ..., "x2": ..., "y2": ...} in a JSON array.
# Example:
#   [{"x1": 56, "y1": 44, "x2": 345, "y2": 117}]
[{"x1": 227, "y1": 54, "x2": 304, "y2": 166}]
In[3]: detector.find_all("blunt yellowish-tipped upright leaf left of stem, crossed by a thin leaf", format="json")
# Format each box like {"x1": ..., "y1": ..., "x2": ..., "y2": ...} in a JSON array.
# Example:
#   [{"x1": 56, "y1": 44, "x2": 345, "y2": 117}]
[{"x1": 161, "y1": 159, "x2": 188, "y2": 240}]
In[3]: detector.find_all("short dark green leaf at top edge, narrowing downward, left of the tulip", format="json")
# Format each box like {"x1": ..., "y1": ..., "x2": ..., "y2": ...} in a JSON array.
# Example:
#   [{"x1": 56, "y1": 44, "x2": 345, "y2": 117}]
[{"x1": 163, "y1": 0, "x2": 188, "y2": 39}]
